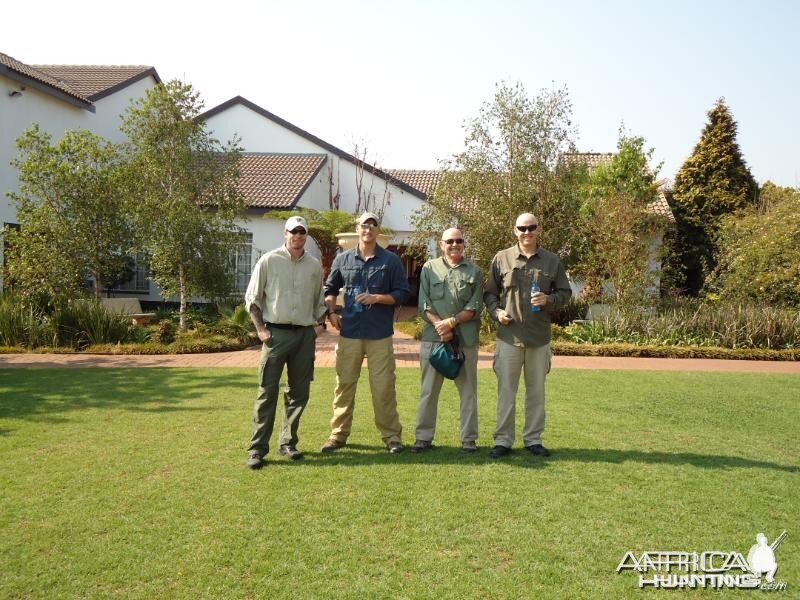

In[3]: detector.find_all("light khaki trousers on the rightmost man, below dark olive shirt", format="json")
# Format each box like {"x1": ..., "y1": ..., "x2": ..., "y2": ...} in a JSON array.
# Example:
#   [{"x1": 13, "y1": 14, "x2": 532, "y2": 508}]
[{"x1": 492, "y1": 340, "x2": 551, "y2": 448}]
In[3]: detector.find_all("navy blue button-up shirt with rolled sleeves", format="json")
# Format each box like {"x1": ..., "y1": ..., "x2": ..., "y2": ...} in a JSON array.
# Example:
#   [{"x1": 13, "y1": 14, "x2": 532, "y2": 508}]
[{"x1": 325, "y1": 246, "x2": 409, "y2": 340}]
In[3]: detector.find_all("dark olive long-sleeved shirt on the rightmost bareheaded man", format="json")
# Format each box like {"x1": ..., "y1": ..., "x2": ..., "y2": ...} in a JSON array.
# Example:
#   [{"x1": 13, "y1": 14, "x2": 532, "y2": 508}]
[{"x1": 483, "y1": 245, "x2": 572, "y2": 346}]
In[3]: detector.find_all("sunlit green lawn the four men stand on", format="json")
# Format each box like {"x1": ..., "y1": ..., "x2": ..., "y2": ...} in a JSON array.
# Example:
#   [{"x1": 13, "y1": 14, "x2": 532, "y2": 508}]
[{"x1": 0, "y1": 369, "x2": 800, "y2": 599}]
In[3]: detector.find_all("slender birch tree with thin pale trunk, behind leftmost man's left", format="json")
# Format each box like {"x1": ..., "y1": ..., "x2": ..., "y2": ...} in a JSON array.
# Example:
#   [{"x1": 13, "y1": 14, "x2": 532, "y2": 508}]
[{"x1": 122, "y1": 81, "x2": 244, "y2": 331}]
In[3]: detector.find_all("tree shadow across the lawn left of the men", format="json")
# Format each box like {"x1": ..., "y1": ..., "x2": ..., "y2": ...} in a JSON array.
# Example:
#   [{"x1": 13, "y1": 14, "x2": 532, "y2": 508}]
[{"x1": 0, "y1": 368, "x2": 254, "y2": 424}]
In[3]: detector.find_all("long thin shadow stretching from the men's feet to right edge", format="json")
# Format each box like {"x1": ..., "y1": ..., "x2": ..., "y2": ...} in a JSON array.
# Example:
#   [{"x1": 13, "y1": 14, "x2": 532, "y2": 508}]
[{"x1": 258, "y1": 444, "x2": 800, "y2": 473}]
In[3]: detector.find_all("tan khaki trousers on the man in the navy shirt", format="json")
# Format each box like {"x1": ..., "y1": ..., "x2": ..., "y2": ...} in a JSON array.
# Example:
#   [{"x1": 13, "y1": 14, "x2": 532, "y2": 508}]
[{"x1": 331, "y1": 336, "x2": 403, "y2": 444}]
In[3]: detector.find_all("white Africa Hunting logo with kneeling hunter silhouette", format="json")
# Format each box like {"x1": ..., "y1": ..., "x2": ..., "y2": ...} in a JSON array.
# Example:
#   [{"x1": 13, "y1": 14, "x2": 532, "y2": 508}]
[{"x1": 617, "y1": 531, "x2": 786, "y2": 591}]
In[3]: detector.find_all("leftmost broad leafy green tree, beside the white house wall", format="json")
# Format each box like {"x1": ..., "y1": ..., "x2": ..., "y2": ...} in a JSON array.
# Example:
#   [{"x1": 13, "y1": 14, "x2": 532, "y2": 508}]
[{"x1": 7, "y1": 125, "x2": 134, "y2": 302}]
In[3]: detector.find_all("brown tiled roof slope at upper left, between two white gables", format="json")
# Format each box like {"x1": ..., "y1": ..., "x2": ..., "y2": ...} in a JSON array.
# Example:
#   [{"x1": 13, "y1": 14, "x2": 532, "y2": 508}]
[{"x1": 31, "y1": 65, "x2": 159, "y2": 100}]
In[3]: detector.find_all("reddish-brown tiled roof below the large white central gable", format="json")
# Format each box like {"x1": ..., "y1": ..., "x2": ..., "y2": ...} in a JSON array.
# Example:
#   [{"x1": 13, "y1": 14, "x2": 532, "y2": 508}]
[{"x1": 239, "y1": 152, "x2": 327, "y2": 208}]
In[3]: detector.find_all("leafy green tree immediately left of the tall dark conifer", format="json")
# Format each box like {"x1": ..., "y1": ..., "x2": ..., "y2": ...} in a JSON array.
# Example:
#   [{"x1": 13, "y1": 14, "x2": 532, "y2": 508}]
[{"x1": 573, "y1": 130, "x2": 666, "y2": 302}]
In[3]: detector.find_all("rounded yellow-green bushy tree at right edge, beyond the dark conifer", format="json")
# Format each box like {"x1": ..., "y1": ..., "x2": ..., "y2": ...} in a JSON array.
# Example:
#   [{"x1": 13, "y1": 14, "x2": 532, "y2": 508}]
[{"x1": 709, "y1": 181, "x2": 800, "y2": 307}]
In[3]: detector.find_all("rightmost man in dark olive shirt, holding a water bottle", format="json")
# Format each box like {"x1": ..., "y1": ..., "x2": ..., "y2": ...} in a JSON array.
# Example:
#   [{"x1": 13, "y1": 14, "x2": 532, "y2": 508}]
[{"x1": 483, "y1": 213, "x2": 572, "y2": 458}]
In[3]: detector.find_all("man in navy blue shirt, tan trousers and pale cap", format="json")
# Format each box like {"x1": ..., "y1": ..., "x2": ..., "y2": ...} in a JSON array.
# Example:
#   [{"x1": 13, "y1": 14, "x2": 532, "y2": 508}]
[{"x1": 322, "y1": 212, "x2": 409, "y2": 454}]
